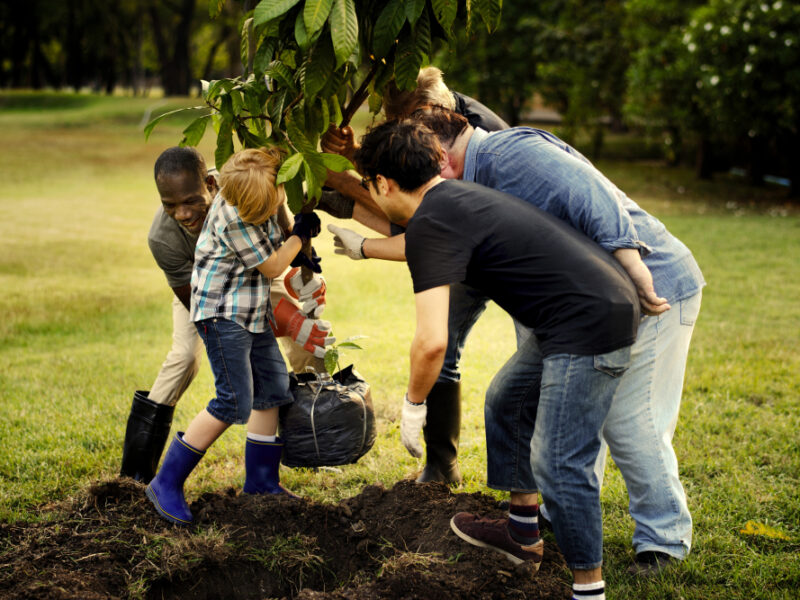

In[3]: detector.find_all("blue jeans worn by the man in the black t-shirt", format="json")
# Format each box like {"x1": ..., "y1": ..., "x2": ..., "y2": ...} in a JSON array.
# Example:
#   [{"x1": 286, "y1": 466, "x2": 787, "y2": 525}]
[{"x1": 484, "y1": 335, "x2": 631, "y2": 569}]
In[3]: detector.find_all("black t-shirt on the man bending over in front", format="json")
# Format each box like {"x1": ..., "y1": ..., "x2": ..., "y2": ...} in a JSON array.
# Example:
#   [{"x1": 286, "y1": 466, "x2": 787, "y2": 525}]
[{"x1": 406, "y1": 179, "x2": 639, "y2": 355}]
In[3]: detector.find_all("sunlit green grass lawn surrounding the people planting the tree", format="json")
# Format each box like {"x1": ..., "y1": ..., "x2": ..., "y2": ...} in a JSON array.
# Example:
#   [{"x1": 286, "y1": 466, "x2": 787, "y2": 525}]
[{"x1": 0, "y1": 94, "x2": 800, "y2": 600}]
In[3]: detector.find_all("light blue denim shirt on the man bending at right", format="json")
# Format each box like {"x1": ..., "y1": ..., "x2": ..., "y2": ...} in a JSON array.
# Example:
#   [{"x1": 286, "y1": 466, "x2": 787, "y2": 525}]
[{"x1": 462, "y1": 127, "x2": 705, "y2": 302}]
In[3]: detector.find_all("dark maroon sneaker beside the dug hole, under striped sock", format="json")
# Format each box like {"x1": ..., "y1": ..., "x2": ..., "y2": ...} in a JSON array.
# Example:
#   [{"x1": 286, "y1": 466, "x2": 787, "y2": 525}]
[{"x1": 450, "y1": 513, "x2": 544, "y2": 573}]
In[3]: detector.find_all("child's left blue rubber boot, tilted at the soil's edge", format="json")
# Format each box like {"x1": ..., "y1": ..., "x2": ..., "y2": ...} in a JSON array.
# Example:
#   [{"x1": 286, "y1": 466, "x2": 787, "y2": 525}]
[{"x1": 145, "y1": 431, "x2": 205, "y2": 525}]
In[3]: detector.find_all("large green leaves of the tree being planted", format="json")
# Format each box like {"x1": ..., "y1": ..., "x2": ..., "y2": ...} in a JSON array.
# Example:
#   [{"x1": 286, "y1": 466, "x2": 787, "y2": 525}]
[{"x1": 146, "y1": 0, "x2": 500, "y2": 212}]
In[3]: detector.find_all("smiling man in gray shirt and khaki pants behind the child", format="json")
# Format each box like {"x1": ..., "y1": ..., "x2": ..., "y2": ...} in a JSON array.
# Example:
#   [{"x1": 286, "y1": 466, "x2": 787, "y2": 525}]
[{"x1": 120, "y1": 146, "x2": 330, "y2": 483}]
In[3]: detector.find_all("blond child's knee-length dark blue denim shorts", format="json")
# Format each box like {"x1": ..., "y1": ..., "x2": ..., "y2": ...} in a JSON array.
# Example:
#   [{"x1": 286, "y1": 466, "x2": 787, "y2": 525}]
[{"x1": 195, "y1": 318, "x2": 294, "y2": 425}]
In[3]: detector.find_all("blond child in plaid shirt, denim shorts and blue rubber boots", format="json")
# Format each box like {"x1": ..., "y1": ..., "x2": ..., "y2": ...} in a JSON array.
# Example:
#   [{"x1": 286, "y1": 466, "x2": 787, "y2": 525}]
[{"x1": 146, "y1": 148, "x2": 329, "y2": 525}]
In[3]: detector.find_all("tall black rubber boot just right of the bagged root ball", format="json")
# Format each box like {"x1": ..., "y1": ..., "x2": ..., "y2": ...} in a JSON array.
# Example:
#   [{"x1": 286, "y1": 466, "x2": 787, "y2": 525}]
[{"x1": 417, "y1": 381, "x2": 461, "y2": 484}]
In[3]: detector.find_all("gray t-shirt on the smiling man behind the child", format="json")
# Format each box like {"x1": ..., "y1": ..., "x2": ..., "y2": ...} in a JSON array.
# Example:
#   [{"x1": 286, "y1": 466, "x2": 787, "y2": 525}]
[{"x1": 147, "y1": 168, "x2": 219, "y2": 288}]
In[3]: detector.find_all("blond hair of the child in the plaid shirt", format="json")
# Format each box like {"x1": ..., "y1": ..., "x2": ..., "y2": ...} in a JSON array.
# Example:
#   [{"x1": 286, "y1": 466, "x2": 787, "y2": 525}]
[{"x1": 219, "y1": 148, "x2": 283, "y2": 225}]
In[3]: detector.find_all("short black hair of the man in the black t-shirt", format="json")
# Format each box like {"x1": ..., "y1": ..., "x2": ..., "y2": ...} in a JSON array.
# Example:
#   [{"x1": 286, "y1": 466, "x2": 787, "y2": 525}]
[{"x1": 354, "y1": 119, "x2": 442, "y2": 192}]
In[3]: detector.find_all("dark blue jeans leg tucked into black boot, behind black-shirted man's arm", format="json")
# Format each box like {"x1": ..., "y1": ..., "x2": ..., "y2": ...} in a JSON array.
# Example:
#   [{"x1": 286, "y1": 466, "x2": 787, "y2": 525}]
[{"x1": 437, "y1": 283, "x2": 489, "y2": 382}]
